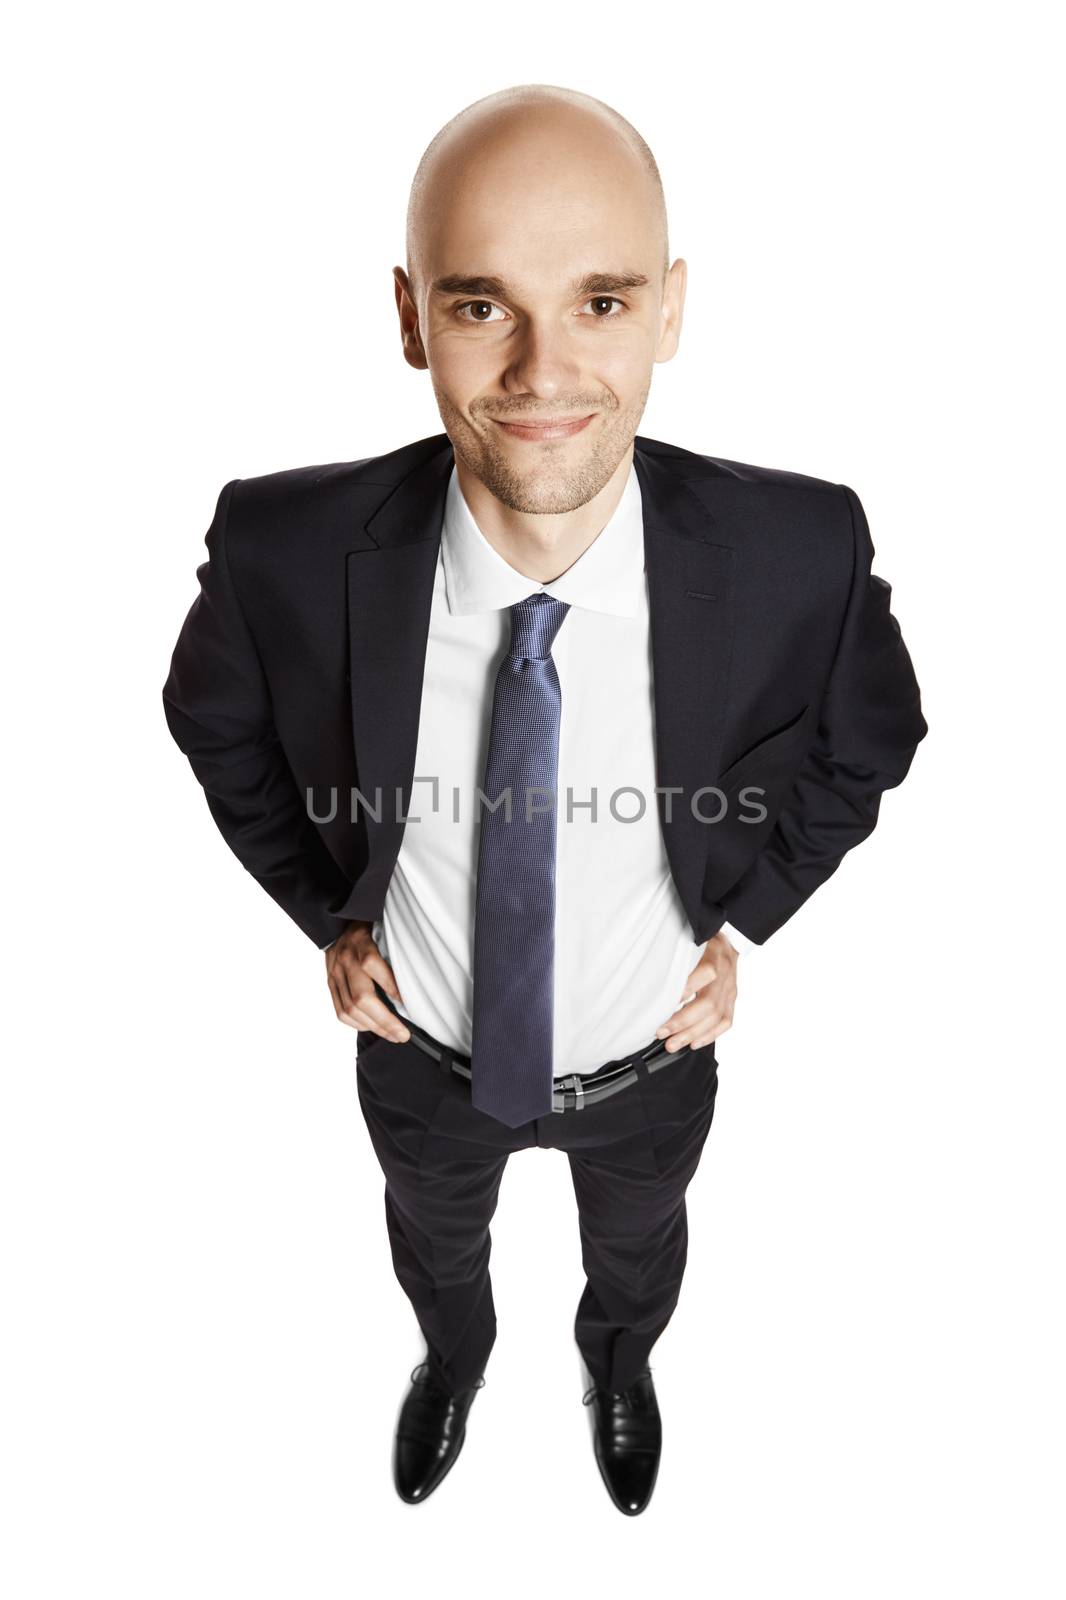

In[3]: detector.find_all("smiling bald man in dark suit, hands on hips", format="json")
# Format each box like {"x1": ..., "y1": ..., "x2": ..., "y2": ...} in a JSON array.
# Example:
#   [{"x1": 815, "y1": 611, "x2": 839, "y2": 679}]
[{"x1": 163, "y1": 85, "x2": 927, "y2": 1515}]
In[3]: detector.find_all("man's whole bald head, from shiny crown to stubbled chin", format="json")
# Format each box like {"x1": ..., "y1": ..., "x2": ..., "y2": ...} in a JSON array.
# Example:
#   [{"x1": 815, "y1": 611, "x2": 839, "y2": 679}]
[{"x1": 392, "y1": 83, "x2": 687, "y2": 518}]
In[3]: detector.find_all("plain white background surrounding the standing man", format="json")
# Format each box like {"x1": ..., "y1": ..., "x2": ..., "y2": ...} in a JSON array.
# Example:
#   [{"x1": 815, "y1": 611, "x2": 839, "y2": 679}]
[{"x1": 0, "y1": 3, "x2": 1066, "y2": 1600}]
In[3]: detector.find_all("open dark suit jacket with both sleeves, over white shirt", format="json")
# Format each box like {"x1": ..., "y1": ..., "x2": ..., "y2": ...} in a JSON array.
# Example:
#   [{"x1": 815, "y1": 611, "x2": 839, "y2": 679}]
[{"x1": 163, "y1": 434, "x2": 927, "y2": 946}]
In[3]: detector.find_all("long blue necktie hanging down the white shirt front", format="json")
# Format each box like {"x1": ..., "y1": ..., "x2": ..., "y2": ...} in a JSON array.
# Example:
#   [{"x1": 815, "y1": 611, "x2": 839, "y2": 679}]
[{"x1": 471, "y1": 592, "x2": 570, "y2": 1128}]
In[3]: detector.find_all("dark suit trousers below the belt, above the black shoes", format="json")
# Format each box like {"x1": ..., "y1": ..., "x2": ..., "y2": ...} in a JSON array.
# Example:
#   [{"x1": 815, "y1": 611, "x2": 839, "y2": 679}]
[{"x1": 357, "y1": 1030, "x2": 719, "y2": 1394}]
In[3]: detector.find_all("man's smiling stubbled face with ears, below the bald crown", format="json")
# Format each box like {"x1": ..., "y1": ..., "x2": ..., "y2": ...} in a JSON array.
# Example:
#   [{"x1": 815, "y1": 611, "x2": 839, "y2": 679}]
[{"x1": 395, "y1": 144, "x2": 685, "y2": 514}]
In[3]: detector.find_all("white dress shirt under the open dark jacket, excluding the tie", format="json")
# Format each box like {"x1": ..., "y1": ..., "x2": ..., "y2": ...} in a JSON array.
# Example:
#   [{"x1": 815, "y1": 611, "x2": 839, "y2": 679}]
[{"x1": 364, "y1": 466, "x2": 731, "y2": 1077}]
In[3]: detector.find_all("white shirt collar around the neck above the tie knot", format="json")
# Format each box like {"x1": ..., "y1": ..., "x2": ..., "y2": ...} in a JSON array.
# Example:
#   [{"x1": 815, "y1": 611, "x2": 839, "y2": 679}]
[{"x1": 440, "y1": 462, "x2": 643, "y2": 618}]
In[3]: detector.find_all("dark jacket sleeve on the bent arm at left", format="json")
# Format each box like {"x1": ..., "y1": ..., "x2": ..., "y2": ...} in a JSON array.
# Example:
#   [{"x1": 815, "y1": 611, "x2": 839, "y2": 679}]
[{"x1": 163, "y1": 478, "x2": 351, "y2": 949}]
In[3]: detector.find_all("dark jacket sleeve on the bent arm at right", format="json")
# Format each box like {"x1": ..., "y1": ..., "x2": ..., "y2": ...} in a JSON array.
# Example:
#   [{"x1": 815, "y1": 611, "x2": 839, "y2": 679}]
[{"x1": 715, "y1": 483, "x2": 928, "y2": 944}]
